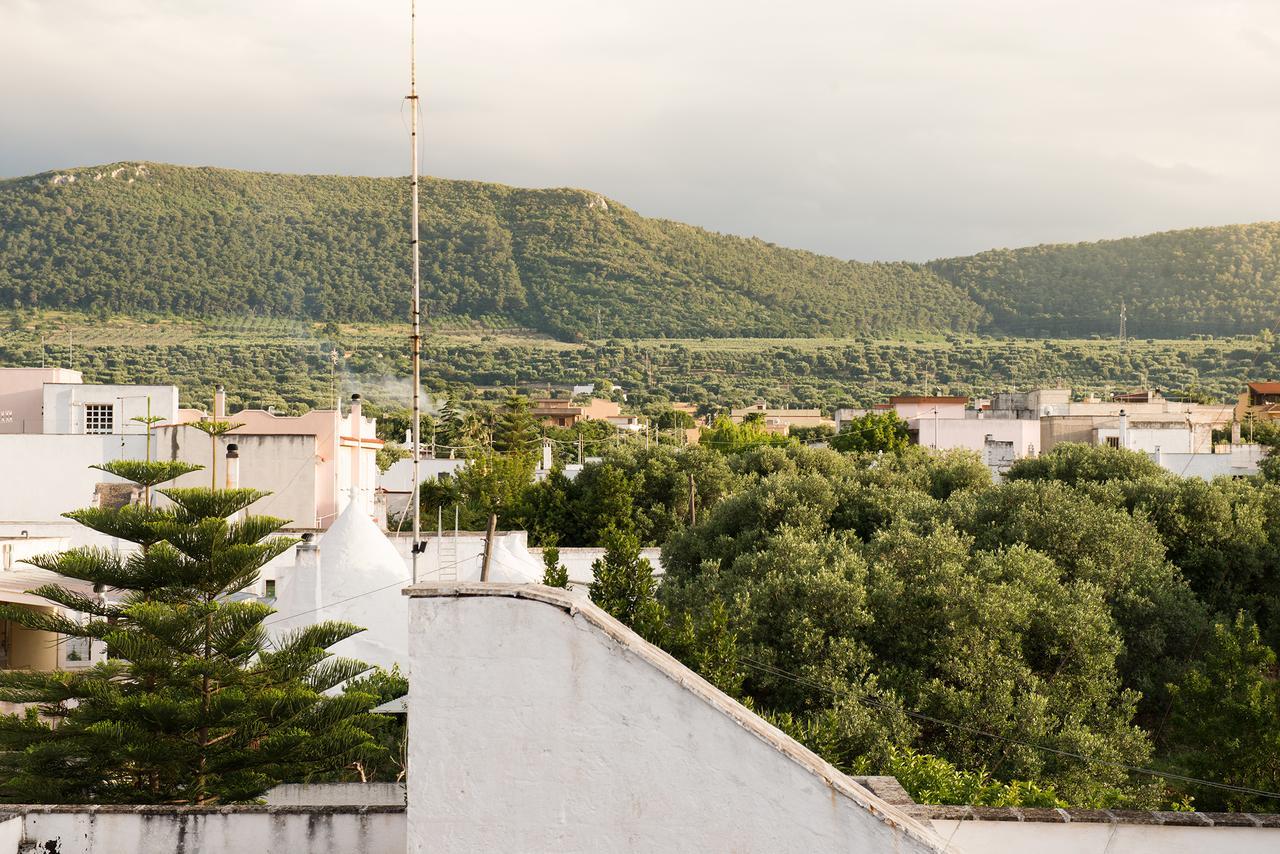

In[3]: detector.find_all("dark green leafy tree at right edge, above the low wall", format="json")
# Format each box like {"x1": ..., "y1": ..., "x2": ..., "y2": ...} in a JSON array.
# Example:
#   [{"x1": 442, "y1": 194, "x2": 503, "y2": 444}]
[{"x1": 1167, "y1": 613, "x2": 1280, "y2": 812}]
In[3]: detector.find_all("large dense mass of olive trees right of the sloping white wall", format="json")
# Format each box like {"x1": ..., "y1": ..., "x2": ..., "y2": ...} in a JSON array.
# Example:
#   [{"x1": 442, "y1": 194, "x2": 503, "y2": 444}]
[{"x1": 658, "y1": 447, "x2": 1280, "y2": 809}]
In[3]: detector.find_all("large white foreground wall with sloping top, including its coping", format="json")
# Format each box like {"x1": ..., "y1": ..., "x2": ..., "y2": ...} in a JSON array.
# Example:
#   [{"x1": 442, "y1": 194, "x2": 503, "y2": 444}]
[{"x1": 408, "y1": 584, "x2": 943, "y2": 854}]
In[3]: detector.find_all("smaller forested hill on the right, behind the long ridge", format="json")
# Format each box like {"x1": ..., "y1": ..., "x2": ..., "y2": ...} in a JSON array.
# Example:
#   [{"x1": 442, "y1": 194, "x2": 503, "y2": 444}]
[{"x1": 928, "y1": 223, "x2": 1280, "y2": 338}]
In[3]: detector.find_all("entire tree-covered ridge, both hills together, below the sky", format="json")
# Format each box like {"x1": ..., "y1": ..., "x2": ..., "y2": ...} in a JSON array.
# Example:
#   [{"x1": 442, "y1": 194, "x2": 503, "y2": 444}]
[{"x1": 0, "y1": 161, "x2": 1280, "y2": 339}]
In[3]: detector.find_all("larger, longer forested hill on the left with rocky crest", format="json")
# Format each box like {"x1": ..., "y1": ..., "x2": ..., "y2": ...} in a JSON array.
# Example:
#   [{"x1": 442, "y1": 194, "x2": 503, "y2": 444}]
[{"x1": 0, "y1": 164, "x2": 984, "y2": 338}]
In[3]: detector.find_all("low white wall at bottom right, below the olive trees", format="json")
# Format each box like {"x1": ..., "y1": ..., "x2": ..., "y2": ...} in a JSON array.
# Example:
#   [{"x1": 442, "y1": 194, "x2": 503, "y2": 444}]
[{"x1": 932, "y1": 819, "x2": 1280, "y2": 854}]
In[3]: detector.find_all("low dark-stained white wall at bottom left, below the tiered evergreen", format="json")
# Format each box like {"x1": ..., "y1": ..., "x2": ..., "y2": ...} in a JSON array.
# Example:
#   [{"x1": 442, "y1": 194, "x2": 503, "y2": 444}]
[{"x1": 15, "y1": 807, "x2": 404, "y2": 854}]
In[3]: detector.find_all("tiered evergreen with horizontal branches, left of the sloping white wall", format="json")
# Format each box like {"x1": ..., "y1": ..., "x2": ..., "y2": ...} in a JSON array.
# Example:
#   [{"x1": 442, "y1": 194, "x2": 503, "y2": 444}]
[{"x1": 0, "y1": 462, "x2": 375, "y2": 804}]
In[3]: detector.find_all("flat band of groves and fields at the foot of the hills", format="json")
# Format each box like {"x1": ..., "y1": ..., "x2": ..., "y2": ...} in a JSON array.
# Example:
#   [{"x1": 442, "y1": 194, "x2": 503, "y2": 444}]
[{"x1": 0, "y1": 312, "x2": 1280, "y2": 411}]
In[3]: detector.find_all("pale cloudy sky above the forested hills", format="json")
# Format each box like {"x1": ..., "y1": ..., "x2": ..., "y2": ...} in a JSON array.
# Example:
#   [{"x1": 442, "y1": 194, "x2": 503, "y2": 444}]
[{"x1": 0, "y1": 0, "x2": 1280, "y2": 260}]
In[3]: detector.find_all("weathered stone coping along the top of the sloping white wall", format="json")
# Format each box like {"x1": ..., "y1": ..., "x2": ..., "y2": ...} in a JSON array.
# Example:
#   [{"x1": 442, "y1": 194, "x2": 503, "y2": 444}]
[{"x1": 403, "y1": 583, "x2": 947, "y2": 851}]
